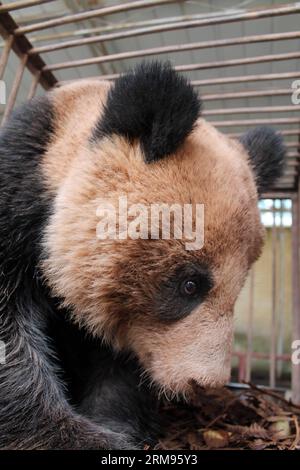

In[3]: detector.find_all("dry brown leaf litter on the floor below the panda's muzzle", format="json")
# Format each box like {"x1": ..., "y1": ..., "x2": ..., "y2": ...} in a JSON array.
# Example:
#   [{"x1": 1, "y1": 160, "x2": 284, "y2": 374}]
[{"x1": 152, "y1": 384, "x2": 300, "y2": 450}]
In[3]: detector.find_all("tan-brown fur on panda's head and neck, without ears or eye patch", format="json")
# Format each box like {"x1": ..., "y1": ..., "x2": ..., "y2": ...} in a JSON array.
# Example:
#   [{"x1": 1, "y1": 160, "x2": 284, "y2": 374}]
[{"x1": 43, "y1": 82, "x2": 263, "y2": 393}]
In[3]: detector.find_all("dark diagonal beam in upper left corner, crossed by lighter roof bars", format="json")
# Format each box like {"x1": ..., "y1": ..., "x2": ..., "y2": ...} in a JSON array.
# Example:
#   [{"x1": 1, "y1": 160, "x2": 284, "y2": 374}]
[{"x1": 0, "y1": 12, "x2": 57, "y2": 89}]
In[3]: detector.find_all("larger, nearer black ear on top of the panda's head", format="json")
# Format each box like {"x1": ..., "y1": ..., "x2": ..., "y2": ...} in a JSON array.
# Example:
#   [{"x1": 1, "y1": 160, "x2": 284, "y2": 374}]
[{"x1": 93, "y1": 62, "x2": 201, "y2": 162}]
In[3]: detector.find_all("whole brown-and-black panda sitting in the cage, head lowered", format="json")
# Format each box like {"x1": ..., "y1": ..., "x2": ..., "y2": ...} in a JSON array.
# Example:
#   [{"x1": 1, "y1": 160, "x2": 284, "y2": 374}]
[{"x1": 0, "y1": 62, "x2": 285, "y2": 449}]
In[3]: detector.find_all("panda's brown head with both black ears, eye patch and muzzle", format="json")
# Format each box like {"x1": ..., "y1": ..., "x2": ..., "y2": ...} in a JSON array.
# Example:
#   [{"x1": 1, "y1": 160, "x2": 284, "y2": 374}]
[{"x1": 44, "y1": 63, "x2": 284, "y2": 392}]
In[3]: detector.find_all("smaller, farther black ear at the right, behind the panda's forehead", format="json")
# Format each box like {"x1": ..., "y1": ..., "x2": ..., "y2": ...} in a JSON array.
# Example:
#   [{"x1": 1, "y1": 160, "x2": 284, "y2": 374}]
[{"x1": 240, "y1": 127, "x2": 286, "y2": 193}]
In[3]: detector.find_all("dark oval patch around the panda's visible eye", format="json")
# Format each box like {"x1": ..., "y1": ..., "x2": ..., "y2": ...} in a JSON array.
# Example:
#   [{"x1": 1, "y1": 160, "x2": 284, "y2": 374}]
[{"x1": 154, "y1": 263, "x2": 213, "y2": 321}]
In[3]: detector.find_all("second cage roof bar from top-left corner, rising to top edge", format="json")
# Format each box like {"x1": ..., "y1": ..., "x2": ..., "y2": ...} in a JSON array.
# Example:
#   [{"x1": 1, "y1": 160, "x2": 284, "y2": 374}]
[{"x1": 16, "y1": 0, "x2": 177, "y2": 36}]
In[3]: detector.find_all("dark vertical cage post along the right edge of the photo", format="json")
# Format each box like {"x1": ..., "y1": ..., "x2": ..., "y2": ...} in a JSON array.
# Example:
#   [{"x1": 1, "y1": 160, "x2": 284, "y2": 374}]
[{"x1": 292, "y1": 187, "x2": 300, "y2": 404}]
